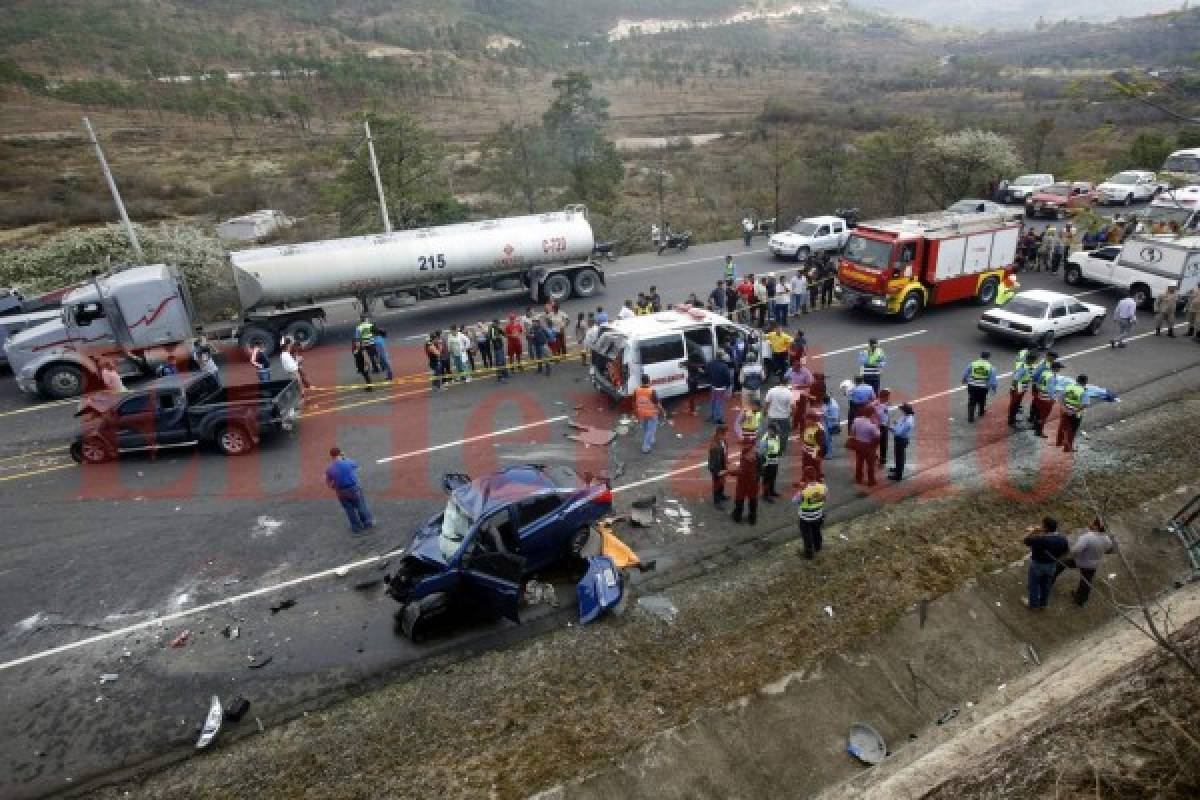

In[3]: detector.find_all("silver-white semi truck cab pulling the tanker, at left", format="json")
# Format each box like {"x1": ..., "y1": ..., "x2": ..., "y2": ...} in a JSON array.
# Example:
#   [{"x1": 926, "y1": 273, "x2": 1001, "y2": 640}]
[{"x1": 4, "y1": 264, "x2": 193, "y2": 399}]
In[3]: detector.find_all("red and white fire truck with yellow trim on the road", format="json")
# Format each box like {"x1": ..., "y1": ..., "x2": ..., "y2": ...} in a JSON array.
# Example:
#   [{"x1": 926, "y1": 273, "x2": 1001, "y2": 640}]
[{"x1": 838, "y1": 212, "x2": 1020, "y2": 321}]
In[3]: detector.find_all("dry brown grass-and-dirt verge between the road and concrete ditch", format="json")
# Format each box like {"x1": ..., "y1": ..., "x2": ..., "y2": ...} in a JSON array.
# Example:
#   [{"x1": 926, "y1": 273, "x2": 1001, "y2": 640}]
[{"x1": 88, "y1": 397, "x2": 1200, "y2": 800}]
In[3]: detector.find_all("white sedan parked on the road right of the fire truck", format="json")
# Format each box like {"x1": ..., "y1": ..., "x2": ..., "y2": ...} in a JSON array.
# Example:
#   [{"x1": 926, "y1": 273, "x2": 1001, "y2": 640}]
[{"x1": 979, "y1": 289, "x2": 1108, "y2": 348}]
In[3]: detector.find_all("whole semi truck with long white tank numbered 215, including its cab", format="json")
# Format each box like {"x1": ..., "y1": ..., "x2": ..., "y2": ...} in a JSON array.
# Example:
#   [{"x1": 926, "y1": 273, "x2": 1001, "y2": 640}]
[{"x1": 4, "y1": 206, "x2": 604, "y2": 399}]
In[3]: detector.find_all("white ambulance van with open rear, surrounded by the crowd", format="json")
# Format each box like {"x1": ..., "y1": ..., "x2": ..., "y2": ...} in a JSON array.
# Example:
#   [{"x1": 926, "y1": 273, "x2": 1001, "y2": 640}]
[{"x1": 592, "y1": 306, "x2": 763, "y2": 401}]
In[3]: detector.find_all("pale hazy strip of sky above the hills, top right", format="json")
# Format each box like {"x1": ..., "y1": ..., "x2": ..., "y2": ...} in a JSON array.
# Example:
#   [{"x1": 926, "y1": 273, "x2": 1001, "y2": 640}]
[{"x1": 853, "y1": 0, "x2": 1188, "y2": 30}]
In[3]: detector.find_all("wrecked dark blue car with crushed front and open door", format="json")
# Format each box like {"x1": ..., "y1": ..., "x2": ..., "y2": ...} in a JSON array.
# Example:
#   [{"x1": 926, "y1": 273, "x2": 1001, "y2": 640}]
[{"x1": 386, "y1": 464, "x2": 612, "y2": 640}]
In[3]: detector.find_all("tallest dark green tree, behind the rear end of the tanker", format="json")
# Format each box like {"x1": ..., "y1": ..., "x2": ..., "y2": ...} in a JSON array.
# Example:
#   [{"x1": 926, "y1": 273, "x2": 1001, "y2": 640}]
[{"x1": 542, "y1": 72, "x2": 624, "y2": 210}]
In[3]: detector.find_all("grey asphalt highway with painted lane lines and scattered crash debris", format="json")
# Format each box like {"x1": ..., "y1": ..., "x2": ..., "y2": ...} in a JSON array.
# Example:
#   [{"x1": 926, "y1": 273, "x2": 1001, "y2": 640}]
[{"x1": 0, "y1": 214, "x2": 1200, "y2": 798}]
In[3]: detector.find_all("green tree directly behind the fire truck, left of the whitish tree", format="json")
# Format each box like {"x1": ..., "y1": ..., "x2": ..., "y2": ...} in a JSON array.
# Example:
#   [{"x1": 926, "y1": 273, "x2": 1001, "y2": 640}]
[{"x1": 854, "y1": 116, "x2": 937, "y2": 213}]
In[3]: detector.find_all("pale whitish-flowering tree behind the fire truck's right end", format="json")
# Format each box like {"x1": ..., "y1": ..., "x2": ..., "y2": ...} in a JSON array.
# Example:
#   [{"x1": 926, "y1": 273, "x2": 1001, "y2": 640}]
[{"x1": 925, "y1": 130, "x2": 1019, "y2": 206}]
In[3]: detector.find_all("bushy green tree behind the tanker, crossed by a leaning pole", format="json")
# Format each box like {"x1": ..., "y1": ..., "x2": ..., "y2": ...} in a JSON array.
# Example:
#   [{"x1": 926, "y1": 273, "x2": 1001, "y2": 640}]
[{"x1": 325, "y1": 112, "x2": 467, "y2": 234}]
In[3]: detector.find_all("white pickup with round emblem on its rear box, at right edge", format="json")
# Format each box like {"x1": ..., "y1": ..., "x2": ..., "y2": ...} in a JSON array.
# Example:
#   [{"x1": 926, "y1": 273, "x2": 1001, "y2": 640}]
[{"x1": 1063, "y1": 235, "x2": 1200, "y2": 308}]
